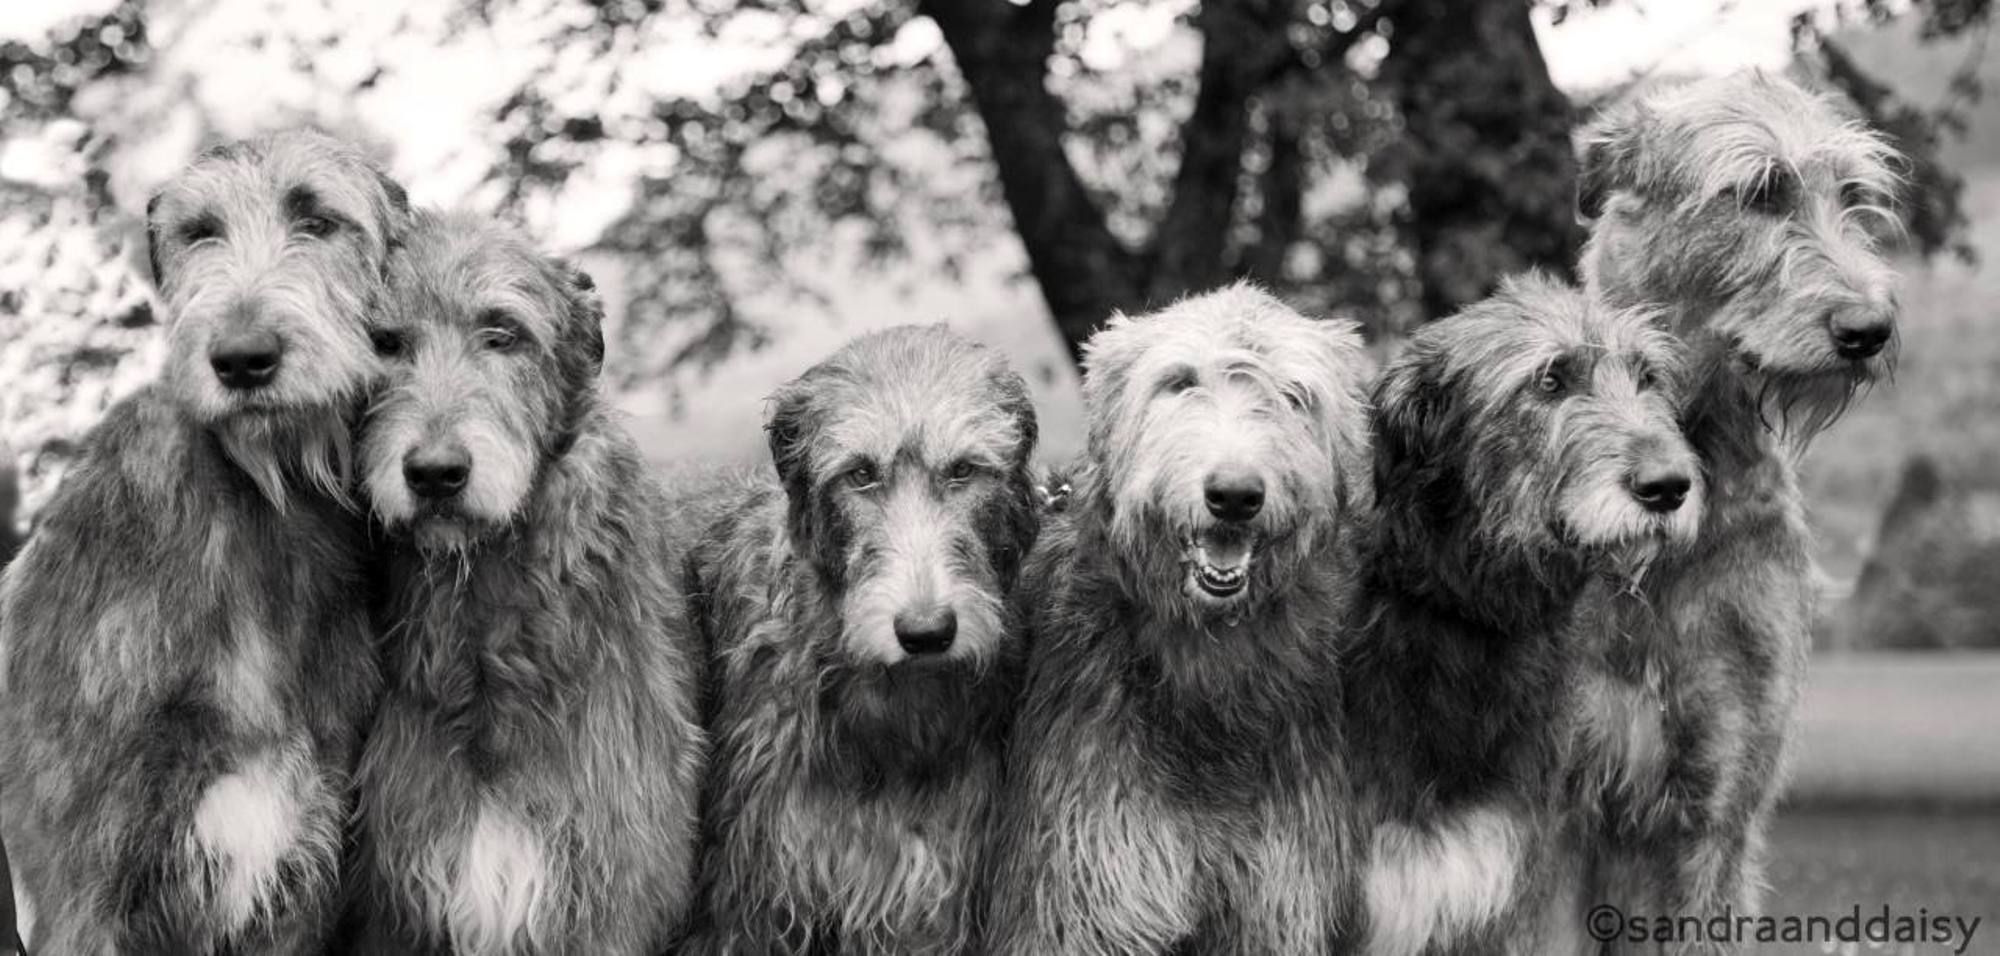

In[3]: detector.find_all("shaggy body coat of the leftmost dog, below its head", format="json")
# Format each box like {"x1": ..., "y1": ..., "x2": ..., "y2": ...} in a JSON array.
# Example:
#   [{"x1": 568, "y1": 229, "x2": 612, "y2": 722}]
[{"x1": 0, "y1": 388, "x2": 376, "y2": 954}]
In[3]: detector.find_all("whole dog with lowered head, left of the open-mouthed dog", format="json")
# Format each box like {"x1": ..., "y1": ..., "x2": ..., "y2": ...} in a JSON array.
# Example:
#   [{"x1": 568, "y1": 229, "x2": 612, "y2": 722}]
[{"x1": 690, "y1": 328, "x2": 1038, "y2": 956}]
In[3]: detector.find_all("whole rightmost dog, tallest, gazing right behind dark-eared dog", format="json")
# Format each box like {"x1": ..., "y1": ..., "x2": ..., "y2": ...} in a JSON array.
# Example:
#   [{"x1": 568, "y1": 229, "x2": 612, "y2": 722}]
[{"x1": 1578, "y1": 74, "x2": 1896, "y2": 948}]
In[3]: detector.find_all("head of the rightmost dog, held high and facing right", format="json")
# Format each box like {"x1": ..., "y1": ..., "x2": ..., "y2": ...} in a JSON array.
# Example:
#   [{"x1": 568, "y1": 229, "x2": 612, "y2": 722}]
[{"x1": 1578, "y1": 72, "x2": 1900, "y2": 432}]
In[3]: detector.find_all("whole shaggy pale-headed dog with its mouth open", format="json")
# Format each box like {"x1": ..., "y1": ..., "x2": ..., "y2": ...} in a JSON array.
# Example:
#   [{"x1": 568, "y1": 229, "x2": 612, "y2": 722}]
[{"x1": 988, "y1": 286, "x2": 1372, "y2": 956}]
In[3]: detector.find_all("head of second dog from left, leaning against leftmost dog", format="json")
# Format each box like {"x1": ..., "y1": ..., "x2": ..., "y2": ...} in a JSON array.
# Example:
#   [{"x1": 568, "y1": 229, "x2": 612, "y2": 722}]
[{"x1": 362, "y1": 214, "x2": 604, "y2": 552}]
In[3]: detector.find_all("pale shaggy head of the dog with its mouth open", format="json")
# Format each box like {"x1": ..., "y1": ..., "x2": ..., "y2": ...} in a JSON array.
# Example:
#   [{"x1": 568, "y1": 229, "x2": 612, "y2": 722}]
[{"x1": 1074, "y1": 284, "x2": 1372, "y2": 622}]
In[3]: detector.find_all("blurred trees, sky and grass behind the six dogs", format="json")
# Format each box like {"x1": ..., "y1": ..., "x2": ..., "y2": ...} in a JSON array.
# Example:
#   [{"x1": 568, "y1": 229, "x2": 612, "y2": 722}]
[{"x1": 0, "y1": 0, "x2": 2000, "y2": 932}]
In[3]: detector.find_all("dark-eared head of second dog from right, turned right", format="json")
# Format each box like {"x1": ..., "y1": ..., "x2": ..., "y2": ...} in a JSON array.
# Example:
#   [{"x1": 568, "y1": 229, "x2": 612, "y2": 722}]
[{"x1": 1374, "y1": 276, "x2": 1702, "y2": 600}]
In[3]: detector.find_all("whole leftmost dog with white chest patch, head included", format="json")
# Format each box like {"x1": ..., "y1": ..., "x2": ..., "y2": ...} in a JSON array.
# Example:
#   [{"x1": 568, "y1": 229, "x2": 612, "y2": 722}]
[{"x1": 0, "y1": 132, "x2": 408, "y2": 954}]
